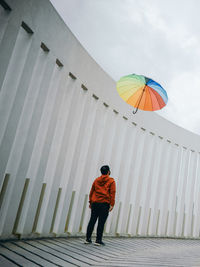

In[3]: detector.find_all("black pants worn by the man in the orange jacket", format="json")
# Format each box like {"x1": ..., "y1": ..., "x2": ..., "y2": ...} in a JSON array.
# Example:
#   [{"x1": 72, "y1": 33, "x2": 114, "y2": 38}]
[{"x1": 86, "y1": 203, "x2": 110, "y2": 241}]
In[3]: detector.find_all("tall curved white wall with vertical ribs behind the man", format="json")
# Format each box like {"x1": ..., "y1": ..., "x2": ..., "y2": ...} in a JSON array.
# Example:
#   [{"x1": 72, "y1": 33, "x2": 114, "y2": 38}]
[{"x1": 0, "y1": 0, "x2": 200, "y2": 241}]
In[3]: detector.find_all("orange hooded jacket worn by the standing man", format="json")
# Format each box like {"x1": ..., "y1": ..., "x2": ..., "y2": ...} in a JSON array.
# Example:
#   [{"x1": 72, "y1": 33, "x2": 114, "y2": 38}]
[{"x1": 89, "y1": 175, "x2": 116, "y2": 206}]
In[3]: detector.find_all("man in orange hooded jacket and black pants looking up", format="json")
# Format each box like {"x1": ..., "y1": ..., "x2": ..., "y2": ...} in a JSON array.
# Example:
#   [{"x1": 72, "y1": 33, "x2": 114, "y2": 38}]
[{"x1": 85, "y1": 165, "x2": 116, "y2": 246}]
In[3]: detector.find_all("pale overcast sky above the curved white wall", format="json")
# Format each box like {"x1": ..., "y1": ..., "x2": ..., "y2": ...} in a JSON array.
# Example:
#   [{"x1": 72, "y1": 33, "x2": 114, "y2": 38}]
[{"x1": 51, "y1": 0, "x2": 200, "y2": 134}]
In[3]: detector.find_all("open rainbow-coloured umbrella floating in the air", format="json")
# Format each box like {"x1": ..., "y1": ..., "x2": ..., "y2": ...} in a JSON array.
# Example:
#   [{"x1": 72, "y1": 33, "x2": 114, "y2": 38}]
[{"x1": 117, "y1": 74, "x2": 168, "y2": 114}]
